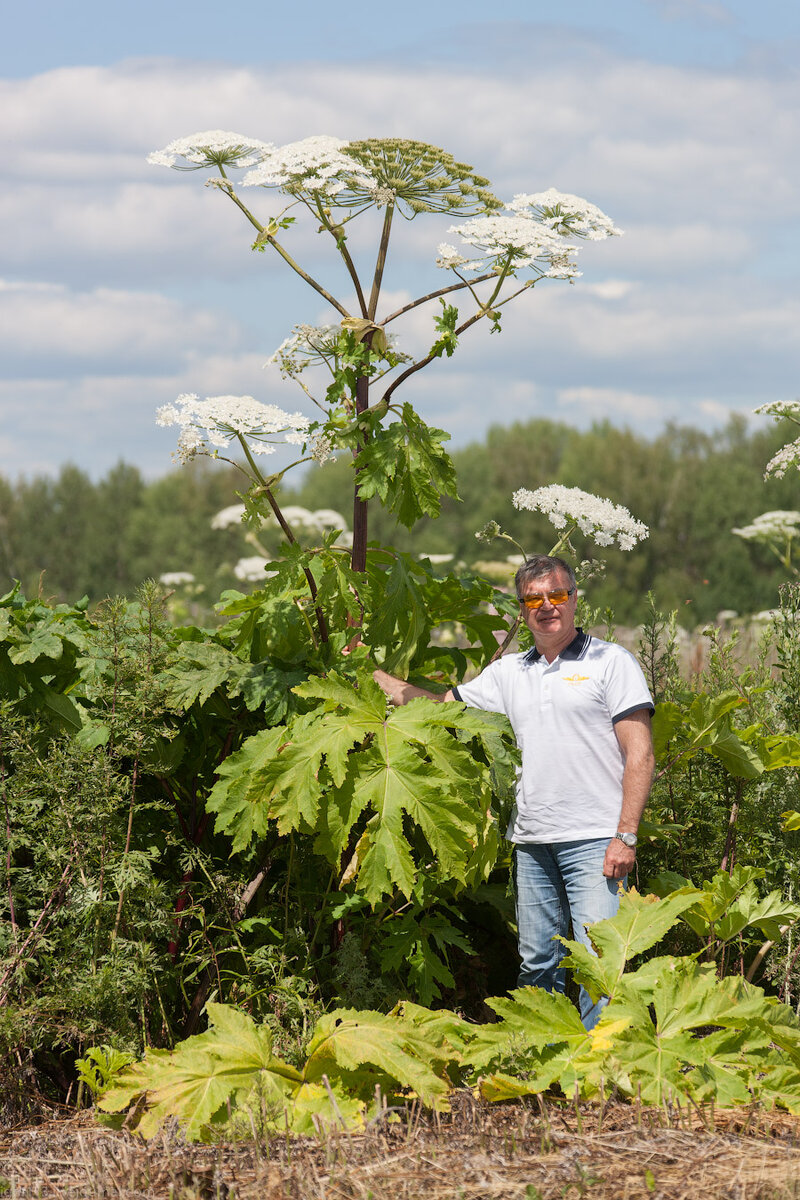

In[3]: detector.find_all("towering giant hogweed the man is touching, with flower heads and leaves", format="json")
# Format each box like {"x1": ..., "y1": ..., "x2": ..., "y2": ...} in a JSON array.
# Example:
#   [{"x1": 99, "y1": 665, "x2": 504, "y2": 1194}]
[{"x1": 140, "y1": 131, "x2": 638, "y2": 1001}]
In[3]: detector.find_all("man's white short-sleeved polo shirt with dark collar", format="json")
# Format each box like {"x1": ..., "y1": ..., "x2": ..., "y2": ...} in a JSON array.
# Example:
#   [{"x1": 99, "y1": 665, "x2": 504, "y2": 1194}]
[{"x1": 453, "y1": 629, "x2": 654, "y2": 842}]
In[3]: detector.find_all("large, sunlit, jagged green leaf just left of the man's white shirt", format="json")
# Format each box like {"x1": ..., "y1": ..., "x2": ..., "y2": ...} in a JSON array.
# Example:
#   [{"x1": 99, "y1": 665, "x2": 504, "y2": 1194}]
[{"x1": 209, "y1": 672, "x2": 509, "y2": 902}]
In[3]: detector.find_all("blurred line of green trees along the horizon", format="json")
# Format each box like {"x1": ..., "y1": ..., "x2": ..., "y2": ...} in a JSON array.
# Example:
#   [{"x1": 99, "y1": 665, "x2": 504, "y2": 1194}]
[{"x1": 0, "y1": 418, "x2": 796, "y2": 626}]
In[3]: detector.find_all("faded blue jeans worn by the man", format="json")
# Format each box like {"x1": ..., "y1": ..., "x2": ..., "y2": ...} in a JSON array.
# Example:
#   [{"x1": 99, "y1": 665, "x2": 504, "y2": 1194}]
[{"x1": 515, "y1": 838, "x2": 625, "y2": 1030}]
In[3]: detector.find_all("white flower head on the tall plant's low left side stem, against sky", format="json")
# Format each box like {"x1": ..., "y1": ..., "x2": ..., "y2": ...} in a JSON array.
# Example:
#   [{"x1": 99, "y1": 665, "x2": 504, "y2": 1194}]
[{"x1": 156, "y1": 394, "x2": 309, "y2": 463}]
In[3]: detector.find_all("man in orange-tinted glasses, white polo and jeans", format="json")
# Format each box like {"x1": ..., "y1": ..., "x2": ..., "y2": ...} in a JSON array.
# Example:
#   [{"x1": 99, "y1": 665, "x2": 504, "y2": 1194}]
[{"x1": 374, "y1": 554, "x2": 654, "y2": 1030}]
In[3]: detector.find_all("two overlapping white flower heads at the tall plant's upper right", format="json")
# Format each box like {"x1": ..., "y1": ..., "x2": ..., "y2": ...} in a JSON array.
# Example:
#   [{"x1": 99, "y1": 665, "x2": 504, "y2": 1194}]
[{"x1": 437, "y1": 188, "x2": 620, "y2": 280}]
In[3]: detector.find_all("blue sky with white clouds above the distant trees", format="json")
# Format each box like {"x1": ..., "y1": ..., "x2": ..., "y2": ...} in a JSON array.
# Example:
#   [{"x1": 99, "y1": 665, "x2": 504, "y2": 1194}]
[{"x1": 0, "y1": 0, "x2": 800, "y2": 480}]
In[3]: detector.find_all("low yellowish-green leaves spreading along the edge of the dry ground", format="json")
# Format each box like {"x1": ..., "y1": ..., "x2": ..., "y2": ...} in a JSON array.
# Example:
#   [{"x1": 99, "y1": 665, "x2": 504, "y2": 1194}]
[{"x1": 101, "y1": 888, "x2": 800, "y2": 1138}]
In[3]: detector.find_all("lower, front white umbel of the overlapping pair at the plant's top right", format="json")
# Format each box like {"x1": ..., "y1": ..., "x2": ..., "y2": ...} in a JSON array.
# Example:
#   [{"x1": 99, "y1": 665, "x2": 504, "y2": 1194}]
[{"x1": 437, "y1": 214, "x2": 581, "y2": 280}]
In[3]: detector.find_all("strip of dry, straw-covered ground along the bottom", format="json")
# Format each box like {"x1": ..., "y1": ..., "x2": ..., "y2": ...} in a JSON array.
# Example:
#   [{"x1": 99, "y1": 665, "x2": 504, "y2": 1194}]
[{"x1": 0, "y1": 1093, "x2": 800, "y2": 1200}]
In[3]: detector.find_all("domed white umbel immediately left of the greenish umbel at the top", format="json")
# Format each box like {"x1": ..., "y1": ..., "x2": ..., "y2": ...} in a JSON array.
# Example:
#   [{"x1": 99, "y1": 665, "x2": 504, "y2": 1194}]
[{"x1": 242, "y1": 134, "x2": 379, "y2": 198}]
